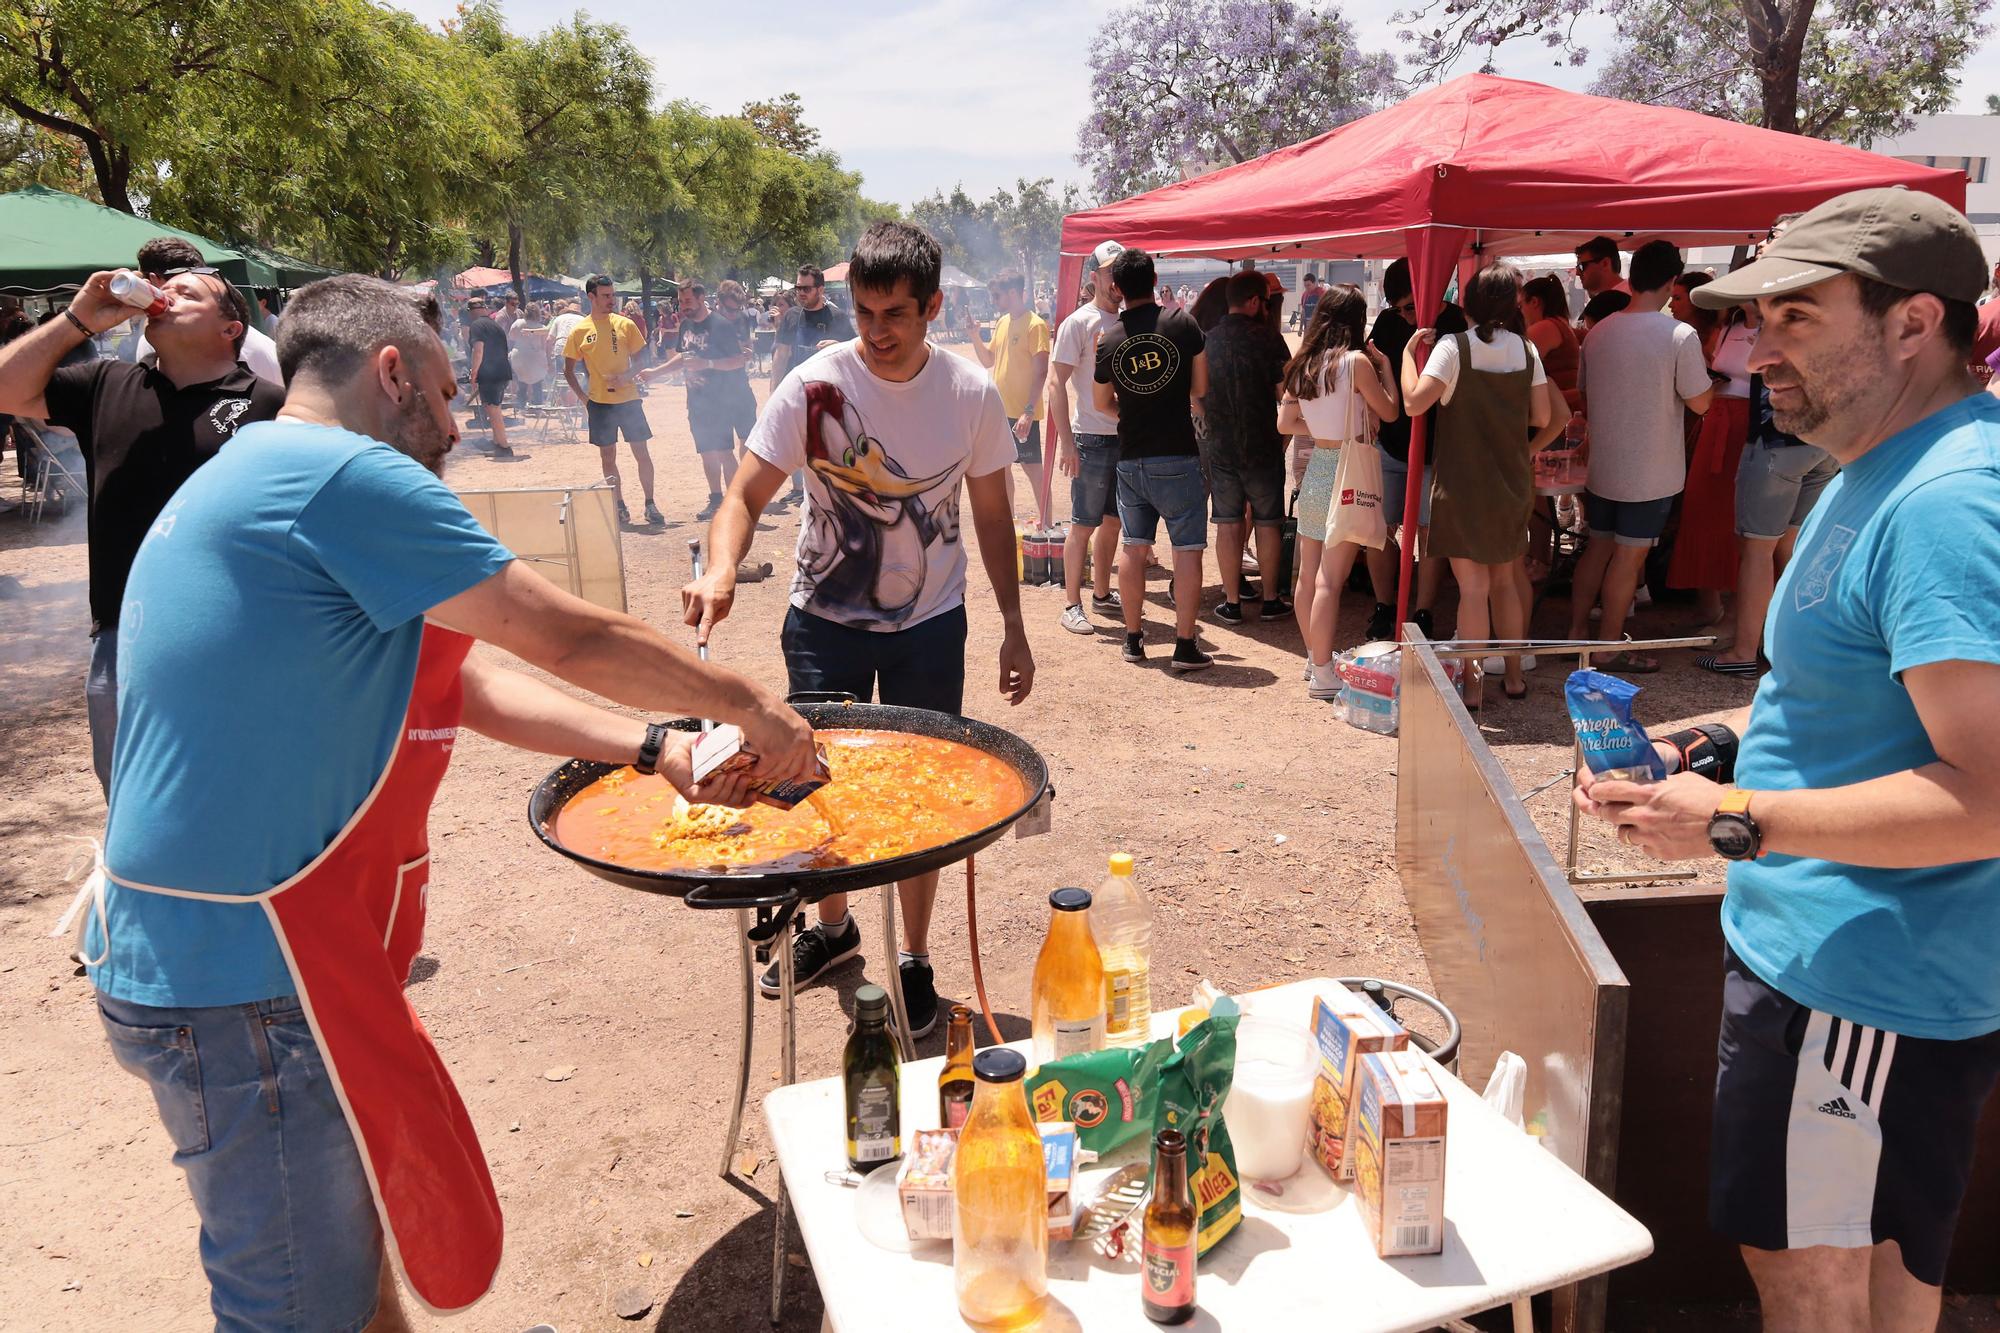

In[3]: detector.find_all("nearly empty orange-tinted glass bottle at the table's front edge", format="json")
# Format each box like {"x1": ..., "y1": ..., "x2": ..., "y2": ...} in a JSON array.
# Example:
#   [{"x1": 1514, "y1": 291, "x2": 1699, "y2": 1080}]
[{"x1": 952, "y1": 1047, "x2": 1048, "y2": 1331}]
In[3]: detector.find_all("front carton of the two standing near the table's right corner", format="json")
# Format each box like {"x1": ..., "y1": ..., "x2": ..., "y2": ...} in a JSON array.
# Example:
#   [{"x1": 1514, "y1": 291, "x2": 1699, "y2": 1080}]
[{"x1": 1350, "y1": 1051, "x2": 1446, "y2": 1259}]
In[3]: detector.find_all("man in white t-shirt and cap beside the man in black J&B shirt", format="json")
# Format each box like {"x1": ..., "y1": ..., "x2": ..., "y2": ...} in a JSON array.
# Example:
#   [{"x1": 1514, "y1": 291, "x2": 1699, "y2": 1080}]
[{"x1": 1048, "y1": 240, "x2": 1124, "y2": 634}]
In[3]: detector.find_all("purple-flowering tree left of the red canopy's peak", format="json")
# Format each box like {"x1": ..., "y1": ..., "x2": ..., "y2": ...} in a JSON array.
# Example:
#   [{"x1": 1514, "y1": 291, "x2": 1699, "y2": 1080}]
[{"x1": 1076, "y1": 0, "x2": 1392, "y2": 198}]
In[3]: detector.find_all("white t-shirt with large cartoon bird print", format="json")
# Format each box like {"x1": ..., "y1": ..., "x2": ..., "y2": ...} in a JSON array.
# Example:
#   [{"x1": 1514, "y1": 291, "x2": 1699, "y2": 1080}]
[{"x1": 746, "y1": 340, "x2": 1014, "y2": 632}]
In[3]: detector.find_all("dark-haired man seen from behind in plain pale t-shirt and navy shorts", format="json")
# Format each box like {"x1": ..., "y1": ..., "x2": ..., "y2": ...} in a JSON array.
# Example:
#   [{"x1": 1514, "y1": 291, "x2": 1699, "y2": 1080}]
[{"x1": 1570, "y1": 240, "x2": 1716, "y2": 673}]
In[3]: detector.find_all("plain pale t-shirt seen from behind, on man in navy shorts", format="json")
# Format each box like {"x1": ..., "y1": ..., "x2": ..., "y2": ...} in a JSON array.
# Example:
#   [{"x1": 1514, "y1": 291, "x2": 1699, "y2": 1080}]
[{"x1": 1578, "y1": 310, "x2": 1708, "y2": 500}]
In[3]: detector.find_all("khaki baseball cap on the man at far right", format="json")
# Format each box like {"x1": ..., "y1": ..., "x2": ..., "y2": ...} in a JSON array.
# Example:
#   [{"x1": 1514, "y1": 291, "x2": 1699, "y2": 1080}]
[{"x1": 1688, "y1": 186, "x2": 1988, "y2": 310}]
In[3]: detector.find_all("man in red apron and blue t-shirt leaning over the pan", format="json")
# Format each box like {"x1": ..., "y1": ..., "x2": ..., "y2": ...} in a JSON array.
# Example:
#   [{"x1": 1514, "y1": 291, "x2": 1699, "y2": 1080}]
[{"x1": 84, "y1": 276, "x2": 814, "y2": 1331}]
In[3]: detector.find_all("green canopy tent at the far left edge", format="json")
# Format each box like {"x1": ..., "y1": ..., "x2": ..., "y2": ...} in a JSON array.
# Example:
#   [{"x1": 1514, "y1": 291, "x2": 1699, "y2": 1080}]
[{"x1": 0, "y1": 186, "x2": 282, "y2": 296}]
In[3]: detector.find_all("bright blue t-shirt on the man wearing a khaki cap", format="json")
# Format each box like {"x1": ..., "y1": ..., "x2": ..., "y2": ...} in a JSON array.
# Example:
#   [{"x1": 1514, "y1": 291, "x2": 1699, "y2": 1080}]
[{"x1": 1722, "y1": 394, "x2": 2000, "y2": 1041}]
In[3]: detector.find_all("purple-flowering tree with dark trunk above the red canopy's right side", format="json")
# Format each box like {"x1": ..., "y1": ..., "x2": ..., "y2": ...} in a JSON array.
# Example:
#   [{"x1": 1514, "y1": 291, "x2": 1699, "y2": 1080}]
[{"x1": 1396, "y1": 0, "x2": 1992, "y2": 144}]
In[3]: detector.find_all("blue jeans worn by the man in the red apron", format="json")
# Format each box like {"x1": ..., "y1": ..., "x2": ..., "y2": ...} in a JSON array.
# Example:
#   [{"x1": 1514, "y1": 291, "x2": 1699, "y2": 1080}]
[{"x1": 98, "y1": 995, "x2": 382, "y2": 1333}]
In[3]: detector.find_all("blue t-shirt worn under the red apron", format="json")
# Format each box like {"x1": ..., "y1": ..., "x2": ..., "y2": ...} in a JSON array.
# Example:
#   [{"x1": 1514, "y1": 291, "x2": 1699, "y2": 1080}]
[{"x1": 86, "y1": 420, "x2": 512, "y2": 1007}]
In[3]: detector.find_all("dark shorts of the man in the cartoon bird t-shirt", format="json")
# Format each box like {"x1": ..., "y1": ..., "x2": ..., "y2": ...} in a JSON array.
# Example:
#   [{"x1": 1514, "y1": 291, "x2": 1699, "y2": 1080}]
[{"x1": 778, "y1": 604, "x2": 966, "y2": 713}]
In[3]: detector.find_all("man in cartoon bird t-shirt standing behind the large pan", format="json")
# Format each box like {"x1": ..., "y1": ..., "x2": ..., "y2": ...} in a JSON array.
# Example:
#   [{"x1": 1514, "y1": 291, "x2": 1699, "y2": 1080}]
[{"x1": 680, "y1": 222, "x2": 1034, "y2": 1037}]
